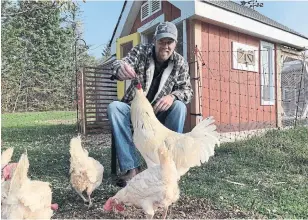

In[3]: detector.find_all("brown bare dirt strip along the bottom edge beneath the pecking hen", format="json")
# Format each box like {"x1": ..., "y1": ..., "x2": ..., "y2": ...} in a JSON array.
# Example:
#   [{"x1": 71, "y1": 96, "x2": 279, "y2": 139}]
[{"x1": 53, "y1": 196, "x2": 257, "y2": 219}]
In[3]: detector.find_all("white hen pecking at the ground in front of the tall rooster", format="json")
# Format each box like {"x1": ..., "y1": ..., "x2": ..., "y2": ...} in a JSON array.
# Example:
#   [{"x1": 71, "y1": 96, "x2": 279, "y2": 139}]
[{"x1": 104, "y1": 144, "x2": 180, "y2": 218}]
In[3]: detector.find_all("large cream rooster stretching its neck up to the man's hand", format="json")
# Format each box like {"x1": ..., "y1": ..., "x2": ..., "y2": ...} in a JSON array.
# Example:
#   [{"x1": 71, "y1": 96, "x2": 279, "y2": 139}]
[{"x1": 131, "y1": 84, "x2": 219, "y2": 176}]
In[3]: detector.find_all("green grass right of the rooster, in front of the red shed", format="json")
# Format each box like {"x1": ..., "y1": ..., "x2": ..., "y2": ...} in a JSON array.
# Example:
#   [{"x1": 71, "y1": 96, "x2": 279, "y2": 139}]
[{"x1": 181, "y1": 128, "x2": 308, "y2": 218}]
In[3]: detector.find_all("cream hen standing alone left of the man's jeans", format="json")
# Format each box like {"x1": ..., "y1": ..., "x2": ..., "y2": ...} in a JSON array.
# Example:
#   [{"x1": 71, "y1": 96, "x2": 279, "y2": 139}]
[{"x1": 70, "y1": 136, "x2": 104, "y2": 207}]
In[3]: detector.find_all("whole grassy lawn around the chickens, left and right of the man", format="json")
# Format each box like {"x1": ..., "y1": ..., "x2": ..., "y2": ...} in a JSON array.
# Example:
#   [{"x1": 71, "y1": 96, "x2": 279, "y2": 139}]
[{"x1": 1, "y1": 112, "x2": 308, "y2": 219}]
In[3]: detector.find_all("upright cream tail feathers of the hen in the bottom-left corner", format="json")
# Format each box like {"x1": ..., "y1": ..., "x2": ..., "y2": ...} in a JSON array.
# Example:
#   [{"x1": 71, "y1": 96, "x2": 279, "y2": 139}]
[{"x1": 9, "y1": 152, "x2": 29, "y2": 194}]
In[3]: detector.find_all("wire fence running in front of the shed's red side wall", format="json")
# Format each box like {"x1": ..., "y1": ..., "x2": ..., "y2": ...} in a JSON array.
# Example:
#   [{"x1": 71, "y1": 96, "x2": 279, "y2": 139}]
[{"x1": 189, "y1": 47, "x2": 308, "y2": 141}]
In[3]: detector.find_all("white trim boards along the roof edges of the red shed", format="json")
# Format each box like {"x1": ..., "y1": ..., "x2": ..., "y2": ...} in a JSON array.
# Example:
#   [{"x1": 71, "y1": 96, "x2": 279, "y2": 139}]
[{"x1": 111, "y1": 0, "x2": 308, "y2": 53}]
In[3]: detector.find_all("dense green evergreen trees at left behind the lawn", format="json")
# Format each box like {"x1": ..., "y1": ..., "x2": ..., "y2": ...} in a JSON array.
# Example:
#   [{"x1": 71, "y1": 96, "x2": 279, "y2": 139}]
[{"x1": 1, "y1": 1, "x2": 74, "y2": 112}]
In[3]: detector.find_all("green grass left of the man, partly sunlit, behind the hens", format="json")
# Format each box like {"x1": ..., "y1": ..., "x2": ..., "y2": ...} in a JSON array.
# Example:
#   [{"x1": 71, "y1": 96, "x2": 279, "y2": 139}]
[{"x1": 1, "y1": 112, "x2": 116, "y2": 217}]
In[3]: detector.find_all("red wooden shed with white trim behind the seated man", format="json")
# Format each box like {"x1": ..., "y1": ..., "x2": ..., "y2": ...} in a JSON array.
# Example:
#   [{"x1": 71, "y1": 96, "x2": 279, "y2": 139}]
[{"x1": 106, "y1": 0, "x2": 308, "y2": 132}]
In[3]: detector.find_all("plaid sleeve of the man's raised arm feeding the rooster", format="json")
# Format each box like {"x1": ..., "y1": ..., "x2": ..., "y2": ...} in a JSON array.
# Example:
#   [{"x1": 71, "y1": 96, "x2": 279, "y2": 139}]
[{"x1": 112, "y1": 44, "x2": 143, "y2": 80}]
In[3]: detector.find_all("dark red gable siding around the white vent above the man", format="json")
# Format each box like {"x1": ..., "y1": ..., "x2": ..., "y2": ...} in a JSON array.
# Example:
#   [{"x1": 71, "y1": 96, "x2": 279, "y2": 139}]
[{"x1": 130, "y1": 1, "x2": 181, "y2": 34}]
